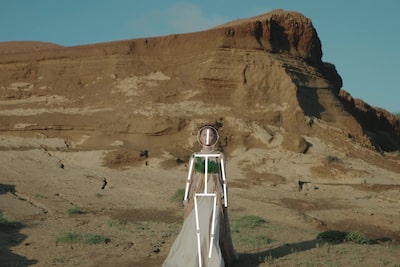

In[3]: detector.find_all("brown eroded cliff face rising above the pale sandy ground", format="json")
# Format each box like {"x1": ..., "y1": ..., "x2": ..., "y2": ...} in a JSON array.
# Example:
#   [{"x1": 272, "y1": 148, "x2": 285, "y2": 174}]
[{"x1": 0, "y1": 10, "x2": 399, "y2": 154}]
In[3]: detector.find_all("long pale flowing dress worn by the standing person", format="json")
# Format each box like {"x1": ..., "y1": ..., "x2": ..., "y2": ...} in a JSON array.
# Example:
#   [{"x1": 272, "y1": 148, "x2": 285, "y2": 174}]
[{"x1": 162, "y1": 156, "x2": 236, "y2": 267}]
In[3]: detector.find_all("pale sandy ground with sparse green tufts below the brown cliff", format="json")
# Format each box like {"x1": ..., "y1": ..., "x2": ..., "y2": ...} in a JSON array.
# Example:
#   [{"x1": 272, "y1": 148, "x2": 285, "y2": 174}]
[{"x1": 0, "y1": 135, "x2": 400, "y2": 266}]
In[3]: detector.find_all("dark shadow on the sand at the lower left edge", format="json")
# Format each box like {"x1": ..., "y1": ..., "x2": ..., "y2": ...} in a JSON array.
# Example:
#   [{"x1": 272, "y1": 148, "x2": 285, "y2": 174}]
[{"x1": 0, "y1": 183, "x2": 38, "y2": 267}]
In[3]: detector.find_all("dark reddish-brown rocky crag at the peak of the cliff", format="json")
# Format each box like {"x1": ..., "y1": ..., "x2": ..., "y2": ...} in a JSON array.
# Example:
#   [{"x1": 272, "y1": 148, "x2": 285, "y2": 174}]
[{"x1": 212, "y1": 10, "x2": 322, "y2": 65}]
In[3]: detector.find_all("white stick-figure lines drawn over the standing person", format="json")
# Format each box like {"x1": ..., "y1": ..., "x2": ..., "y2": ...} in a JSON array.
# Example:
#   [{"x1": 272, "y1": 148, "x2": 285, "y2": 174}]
[{"x1": 184, "y1": 153, "x2": 228, "y2": 267}]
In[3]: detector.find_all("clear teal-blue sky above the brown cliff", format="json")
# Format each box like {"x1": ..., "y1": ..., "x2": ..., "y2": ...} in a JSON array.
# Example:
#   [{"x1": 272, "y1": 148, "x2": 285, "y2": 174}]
[{"x1": 0, "y1": 0, "x2": 400, "y2": 113}]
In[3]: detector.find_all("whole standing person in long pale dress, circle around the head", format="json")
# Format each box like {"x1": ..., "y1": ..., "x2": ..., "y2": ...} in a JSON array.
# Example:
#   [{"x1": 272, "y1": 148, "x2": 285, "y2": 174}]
[{"x1": 162, "y1": 126, "x2": 237, "y2": 267}]
